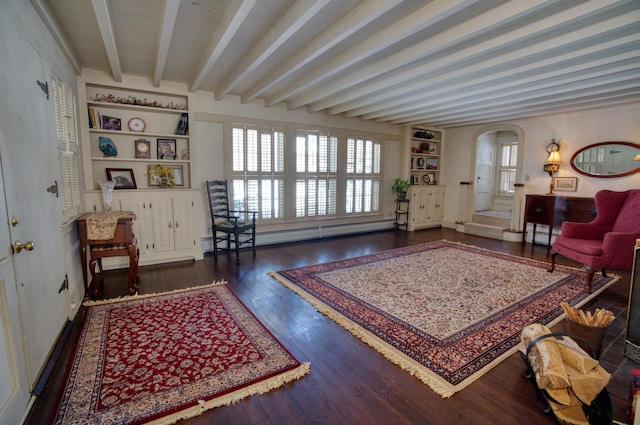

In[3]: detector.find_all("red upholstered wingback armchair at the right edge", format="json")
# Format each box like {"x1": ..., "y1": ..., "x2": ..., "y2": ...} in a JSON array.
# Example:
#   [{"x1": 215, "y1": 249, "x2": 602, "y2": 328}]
[{"x1": 549, "y1": 189, "x2": 640, "y2": 292}]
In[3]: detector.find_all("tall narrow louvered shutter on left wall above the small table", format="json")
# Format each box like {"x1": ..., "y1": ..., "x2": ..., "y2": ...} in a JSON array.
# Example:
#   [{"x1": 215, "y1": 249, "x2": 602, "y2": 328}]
[{"x1": 51, "y1": 77, "x2": 81, "y2": 219}]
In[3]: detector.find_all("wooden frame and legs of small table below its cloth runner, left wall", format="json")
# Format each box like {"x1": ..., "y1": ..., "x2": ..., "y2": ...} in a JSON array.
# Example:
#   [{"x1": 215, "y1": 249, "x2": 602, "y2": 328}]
[{"x1": 89, "y1": 238, "x2": 140, "y2": 296}]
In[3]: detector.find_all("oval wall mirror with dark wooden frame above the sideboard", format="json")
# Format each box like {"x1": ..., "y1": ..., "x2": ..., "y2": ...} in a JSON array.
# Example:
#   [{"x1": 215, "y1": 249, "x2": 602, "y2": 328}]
[{"x1": 571, "y1": 142, "x2": 640, "y2": 178}]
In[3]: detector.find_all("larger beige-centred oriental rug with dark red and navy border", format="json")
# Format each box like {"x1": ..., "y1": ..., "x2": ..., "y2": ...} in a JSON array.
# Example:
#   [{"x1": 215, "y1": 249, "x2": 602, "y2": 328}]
[{"x1": 271, "y1": 241, "x2": 618, "y2": 397}]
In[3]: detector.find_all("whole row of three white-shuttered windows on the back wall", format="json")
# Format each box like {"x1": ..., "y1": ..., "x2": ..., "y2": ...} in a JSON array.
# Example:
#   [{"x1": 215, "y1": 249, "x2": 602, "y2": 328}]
[{"x1": 230, "y1": 124, "x2": 382, "y2": 223}]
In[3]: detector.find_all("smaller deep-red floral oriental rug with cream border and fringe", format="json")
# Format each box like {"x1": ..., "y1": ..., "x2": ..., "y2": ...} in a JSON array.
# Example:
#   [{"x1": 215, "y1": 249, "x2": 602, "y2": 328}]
[{"x1": 53, "y1": 284, "x2": 310, "y2": 424}]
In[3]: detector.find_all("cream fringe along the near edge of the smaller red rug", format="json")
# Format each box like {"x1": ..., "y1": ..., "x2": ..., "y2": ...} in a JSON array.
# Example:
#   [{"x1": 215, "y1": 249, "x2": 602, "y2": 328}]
[{"x1": 149, "y1": 362, "x2": 311, "y2": 425}]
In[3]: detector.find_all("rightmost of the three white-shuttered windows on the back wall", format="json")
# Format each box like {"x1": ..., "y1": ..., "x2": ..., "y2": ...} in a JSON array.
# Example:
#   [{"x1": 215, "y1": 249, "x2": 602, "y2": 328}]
[{"x1": 345, "y1": 137, "x2": 382, "y2": 214}]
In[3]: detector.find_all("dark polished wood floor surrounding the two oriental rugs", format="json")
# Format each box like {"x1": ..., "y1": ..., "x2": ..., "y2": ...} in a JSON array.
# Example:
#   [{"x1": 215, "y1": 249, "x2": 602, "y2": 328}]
[{"x1": 26, "y1": 229, "x2": 639, "y2": 425}]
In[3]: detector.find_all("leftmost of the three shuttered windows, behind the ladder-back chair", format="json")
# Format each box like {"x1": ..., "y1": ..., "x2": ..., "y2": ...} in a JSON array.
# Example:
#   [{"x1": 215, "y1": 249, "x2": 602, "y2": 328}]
[{"x1": 231, "y1": 124, "x2": 285, "y2": 221}]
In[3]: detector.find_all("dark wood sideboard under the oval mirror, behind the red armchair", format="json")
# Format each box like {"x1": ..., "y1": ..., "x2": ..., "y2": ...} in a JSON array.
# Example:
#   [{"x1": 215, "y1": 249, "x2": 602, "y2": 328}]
[{"x1": 522, "y1": 195, "x2": 596, "y2": 246}]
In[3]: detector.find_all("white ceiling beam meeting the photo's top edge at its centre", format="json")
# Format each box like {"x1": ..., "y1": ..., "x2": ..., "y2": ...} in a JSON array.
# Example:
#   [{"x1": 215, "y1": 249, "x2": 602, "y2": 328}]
[{"x1": 214, "y1": 0, "x2": 331, "y2": 100}]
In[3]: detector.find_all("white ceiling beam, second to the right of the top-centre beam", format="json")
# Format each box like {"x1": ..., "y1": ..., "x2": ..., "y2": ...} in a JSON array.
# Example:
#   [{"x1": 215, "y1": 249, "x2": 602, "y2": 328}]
[{"x1": 266, "y1": 0, "x2": 476, "y2": 109}]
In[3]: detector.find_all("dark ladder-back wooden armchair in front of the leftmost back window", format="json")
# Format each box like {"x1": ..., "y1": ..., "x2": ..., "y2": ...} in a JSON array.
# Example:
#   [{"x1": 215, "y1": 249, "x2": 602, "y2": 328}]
[{"x1": 207, "y1": 180, "x2": 258, "y2": 264}]
